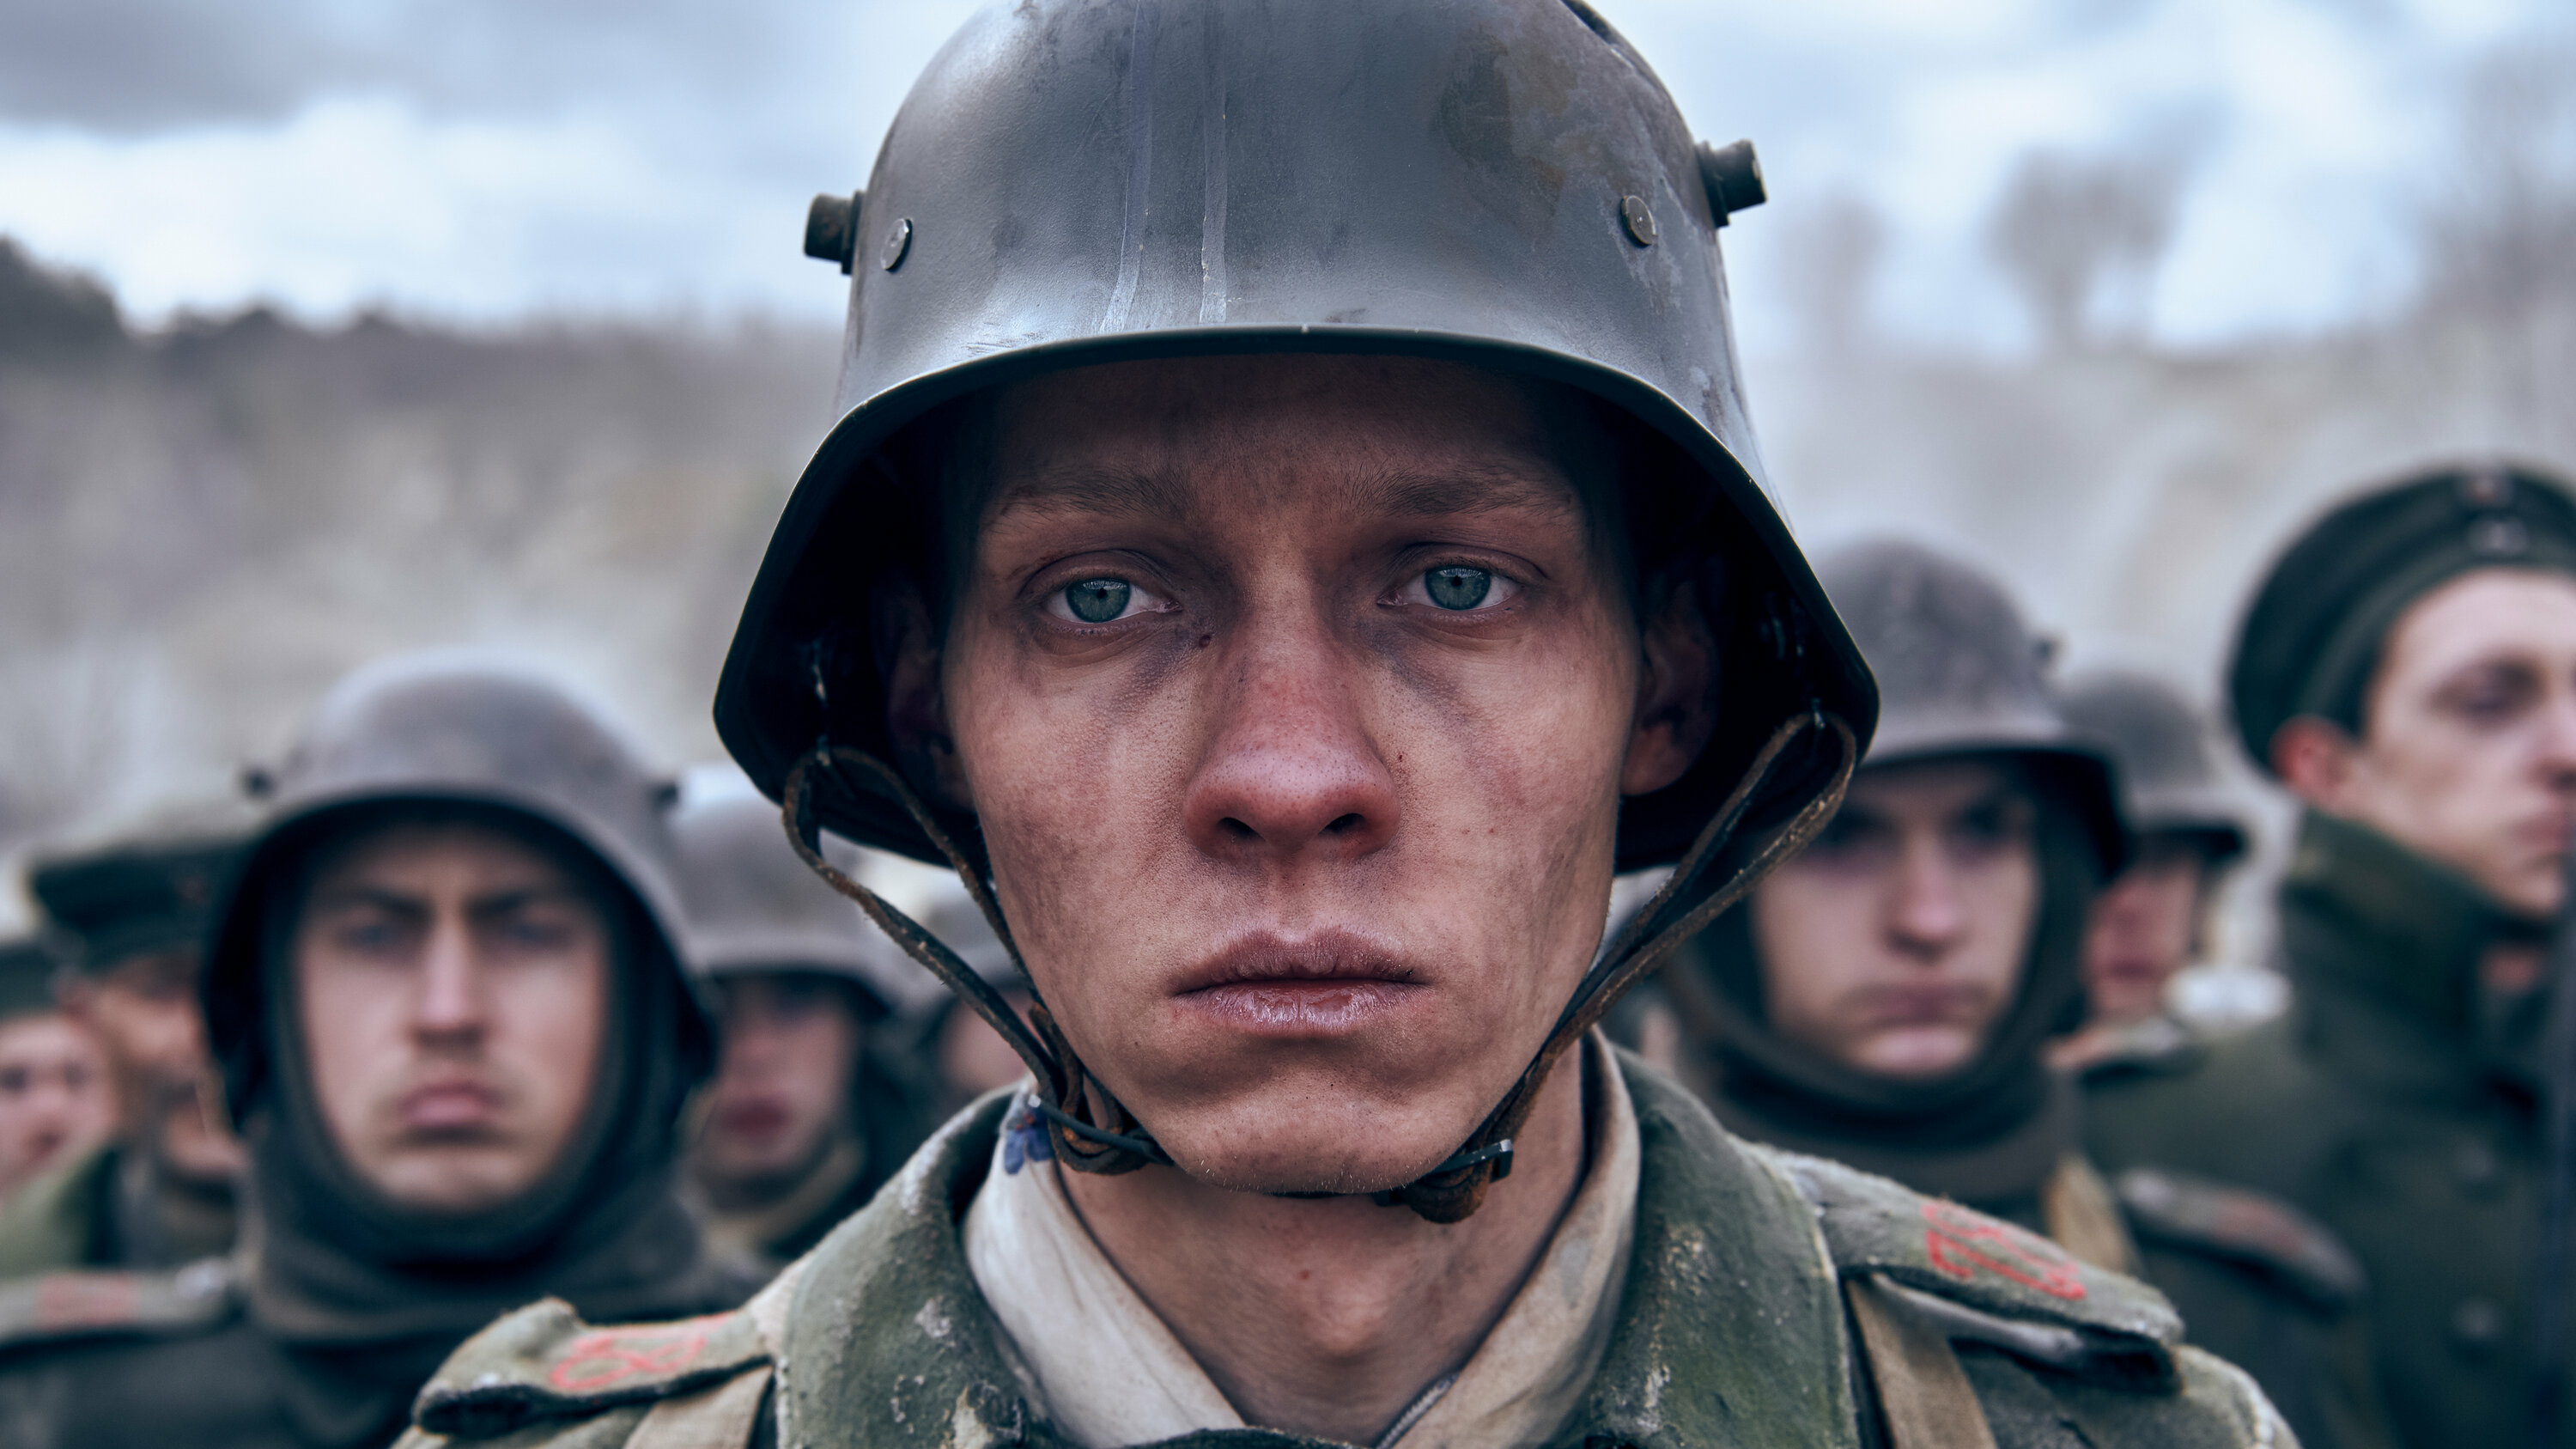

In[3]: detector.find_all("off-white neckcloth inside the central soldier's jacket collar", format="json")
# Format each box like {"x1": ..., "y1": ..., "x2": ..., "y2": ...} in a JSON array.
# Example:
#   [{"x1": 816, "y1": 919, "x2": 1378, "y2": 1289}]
[{"x1": 966, "y1": 1037, "x2": 1638, "y2": 1449}]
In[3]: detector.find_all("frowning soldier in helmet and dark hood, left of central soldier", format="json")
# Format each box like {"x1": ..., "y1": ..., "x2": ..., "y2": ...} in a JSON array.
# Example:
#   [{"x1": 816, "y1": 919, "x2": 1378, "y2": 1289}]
[{"x1": 0, "y1": 657, "x2": 750, "y2": 1449}]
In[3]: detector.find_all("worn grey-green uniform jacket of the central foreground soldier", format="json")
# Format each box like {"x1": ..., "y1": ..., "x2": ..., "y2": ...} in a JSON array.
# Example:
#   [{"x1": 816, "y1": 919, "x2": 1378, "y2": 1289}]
[{"x1": 404, "y1": 1060, "x2": 2293, "y2": 1449}]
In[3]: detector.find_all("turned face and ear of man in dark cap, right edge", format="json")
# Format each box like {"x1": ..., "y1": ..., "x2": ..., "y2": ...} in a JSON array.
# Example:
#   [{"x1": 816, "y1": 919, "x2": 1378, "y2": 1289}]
[{"x1": 2275, "y1": 569, "x2": 2576, "y2": 916}]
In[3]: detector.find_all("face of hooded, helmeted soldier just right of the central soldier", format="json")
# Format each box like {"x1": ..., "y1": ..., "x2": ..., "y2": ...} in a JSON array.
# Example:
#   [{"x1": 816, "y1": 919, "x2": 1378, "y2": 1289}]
[{"x1": 1752, "y1": 761, "x2": 2040, "y2": 1078}]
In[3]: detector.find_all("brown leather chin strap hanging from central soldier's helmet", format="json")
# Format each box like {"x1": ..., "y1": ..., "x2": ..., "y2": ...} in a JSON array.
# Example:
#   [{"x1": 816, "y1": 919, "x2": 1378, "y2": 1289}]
[{"x1": 781, "y1": 711, "x2": 1860, "y2": 1222}]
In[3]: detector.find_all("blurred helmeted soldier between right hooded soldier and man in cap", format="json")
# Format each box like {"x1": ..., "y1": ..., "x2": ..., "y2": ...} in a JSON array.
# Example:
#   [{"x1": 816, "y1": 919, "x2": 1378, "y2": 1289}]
[{"x1": 2050, "y1": 670, "x2": 2246, "y2": 1073}]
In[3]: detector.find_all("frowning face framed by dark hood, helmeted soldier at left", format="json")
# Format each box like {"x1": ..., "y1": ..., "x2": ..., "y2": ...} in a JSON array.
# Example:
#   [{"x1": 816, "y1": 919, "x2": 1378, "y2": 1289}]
[{"x1": 294, "y1": 823, "x2": 611, "y2": 1215}]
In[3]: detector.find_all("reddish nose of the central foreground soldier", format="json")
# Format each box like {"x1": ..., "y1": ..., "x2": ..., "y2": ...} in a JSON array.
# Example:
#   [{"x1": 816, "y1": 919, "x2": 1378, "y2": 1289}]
[{"x1": 1182, "y1": 606, "x2": 1401, "y2": 864}]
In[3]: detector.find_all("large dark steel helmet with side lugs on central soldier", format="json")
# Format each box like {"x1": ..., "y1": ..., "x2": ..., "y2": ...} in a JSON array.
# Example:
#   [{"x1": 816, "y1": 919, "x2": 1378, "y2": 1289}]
[{"x1": 716, "y1": 0, "x2": 1873, "y2": 869}]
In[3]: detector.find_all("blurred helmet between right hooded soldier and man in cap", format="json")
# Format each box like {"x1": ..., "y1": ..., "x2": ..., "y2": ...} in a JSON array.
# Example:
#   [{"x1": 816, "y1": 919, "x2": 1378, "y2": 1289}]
[{"x1": 2058, "y1": 670, "x2": 2246, "y2": 867}]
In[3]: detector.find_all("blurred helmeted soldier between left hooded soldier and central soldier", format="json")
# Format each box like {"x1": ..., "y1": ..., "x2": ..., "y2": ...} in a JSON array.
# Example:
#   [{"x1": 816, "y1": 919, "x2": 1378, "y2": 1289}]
[{"x1": 672, "y1": 795, "x2": 938, "y2": 1263}]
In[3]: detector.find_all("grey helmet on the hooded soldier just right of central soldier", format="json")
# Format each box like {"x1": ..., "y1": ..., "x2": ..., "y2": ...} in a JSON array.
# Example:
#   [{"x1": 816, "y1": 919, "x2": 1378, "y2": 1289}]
[{"x1": 1819, "y1": 541, "x2": 2128, "y2": 874}]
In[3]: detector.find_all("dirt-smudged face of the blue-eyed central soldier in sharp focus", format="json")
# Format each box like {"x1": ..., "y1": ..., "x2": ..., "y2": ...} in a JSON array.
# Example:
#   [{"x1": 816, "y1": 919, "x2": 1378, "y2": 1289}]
[{"x1": 894, "y1": 358, "x2": 1708, "y2": 1191}]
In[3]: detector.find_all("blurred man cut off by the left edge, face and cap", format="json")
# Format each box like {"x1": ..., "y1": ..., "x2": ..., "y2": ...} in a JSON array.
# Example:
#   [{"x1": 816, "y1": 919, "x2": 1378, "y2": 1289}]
[{"x1": 0, "y1": 939, "x2": 116, "y2": 1196}]
